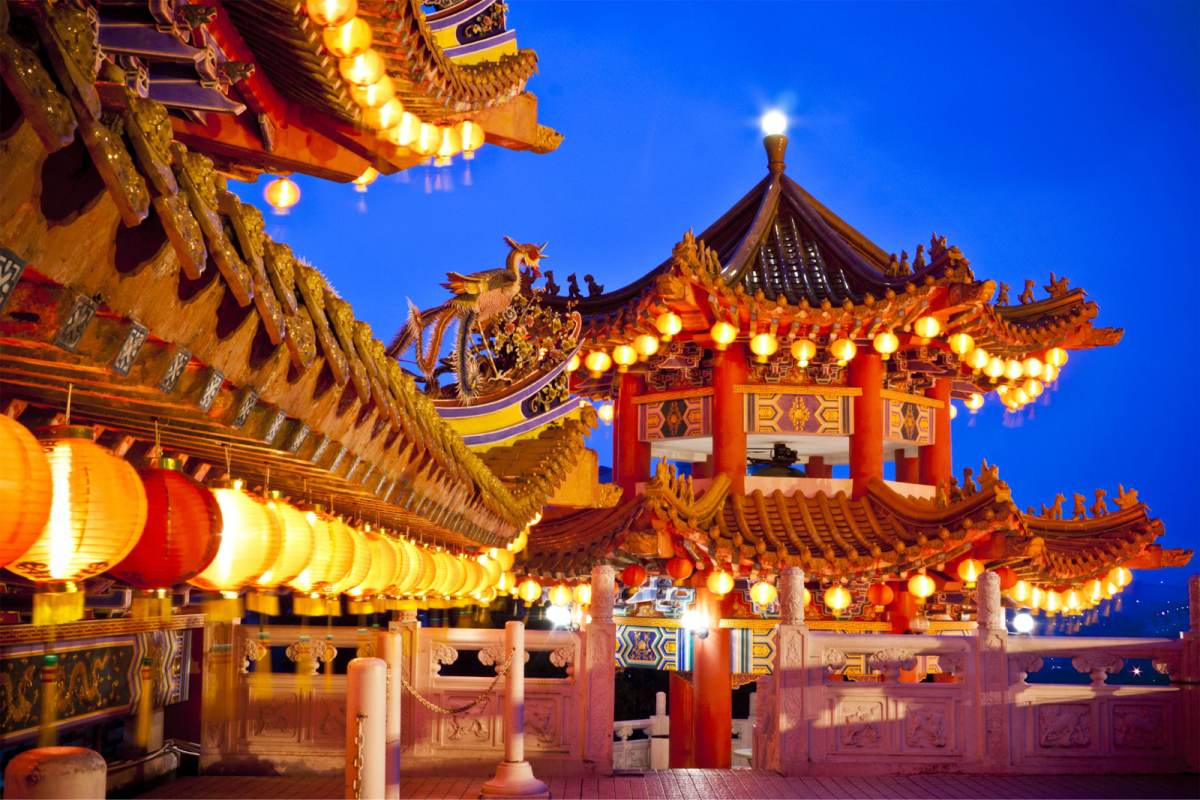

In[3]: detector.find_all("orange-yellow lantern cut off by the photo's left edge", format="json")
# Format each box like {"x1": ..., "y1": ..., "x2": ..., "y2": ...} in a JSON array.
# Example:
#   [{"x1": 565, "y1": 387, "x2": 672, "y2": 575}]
[{"x1": 0, "y1": 414, "x2": 52, "y2": 567}]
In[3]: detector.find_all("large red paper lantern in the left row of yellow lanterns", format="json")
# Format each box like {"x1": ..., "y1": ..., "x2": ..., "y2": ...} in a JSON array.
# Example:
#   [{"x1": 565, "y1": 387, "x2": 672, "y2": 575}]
[{"x1": 108, "y1": 458, "x2": 222, "y2": 591}]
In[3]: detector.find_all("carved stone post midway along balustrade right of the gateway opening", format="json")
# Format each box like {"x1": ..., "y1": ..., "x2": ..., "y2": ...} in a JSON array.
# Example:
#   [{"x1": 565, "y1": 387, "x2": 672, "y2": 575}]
[{"x1": 976, "y1": 572, "x2": 1010, "y2": 771}]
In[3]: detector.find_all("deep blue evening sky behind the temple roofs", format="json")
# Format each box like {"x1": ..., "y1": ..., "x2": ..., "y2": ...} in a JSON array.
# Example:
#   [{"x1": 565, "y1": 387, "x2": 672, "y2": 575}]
[{"x1": 233, "y1": 0, "x2": 1200, "y2": 582}]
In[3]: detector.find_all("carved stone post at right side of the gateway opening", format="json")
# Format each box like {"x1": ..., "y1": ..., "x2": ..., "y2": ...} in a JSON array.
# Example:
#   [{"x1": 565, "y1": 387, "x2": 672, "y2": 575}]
[{"x1": 764, "y1": 566, "x2": 809, "y2": 775}]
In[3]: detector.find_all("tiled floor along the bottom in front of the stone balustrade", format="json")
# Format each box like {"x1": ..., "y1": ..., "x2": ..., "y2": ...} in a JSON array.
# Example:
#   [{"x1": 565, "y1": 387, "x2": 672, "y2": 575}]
[{"x1": 133, "y1": 770, "x2": 1200, "y2": 800}]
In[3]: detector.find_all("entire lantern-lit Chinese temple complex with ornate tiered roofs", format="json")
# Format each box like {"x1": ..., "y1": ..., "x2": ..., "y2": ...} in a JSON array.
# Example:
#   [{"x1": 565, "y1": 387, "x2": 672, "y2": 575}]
[{"x1": 0, "y1": 0, "x2": 1200, "y2": 800}]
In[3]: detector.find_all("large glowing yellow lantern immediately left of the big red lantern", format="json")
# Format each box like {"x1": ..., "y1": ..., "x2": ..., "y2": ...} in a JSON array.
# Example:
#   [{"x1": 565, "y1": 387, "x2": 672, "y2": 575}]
[{"x1": 11, "y1": 423, "x2": 146, "y2": 625}]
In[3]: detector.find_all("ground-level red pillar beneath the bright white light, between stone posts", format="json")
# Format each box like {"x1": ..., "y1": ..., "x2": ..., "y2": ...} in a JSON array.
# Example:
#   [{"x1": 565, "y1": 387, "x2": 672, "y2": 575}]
[{"x1": 691, "y1": 588, "x2": 733, "y2": 770}]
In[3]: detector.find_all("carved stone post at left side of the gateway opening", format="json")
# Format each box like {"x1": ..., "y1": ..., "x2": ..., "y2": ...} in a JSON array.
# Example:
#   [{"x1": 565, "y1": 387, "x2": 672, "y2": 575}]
[{"x1": 583, "y1": 564, "x2": 617, "y2": 775}]
